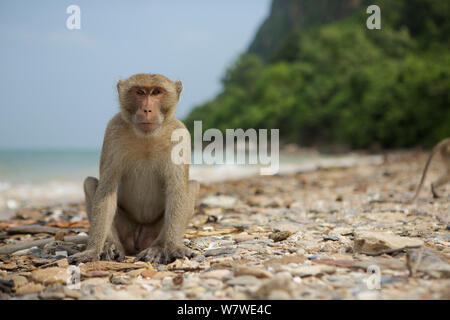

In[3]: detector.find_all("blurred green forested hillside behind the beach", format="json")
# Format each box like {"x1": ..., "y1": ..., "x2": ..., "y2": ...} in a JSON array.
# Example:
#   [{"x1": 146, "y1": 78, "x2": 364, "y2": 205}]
[{"x1": 185, "y1": 0, "x2": 450, "y2": 149}]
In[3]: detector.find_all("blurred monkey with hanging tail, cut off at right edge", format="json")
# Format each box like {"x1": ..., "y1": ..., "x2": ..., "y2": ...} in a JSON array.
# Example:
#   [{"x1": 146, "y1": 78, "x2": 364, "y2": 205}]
[{"x1": 409, "y1": 138, "x2": 450, "y2": 203}]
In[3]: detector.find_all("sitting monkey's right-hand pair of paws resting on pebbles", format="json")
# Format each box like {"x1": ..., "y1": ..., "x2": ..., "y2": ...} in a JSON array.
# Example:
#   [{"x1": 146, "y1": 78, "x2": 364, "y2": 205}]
[{"x1": 134, "y1": 246, "x2": 195, "y2": 264}]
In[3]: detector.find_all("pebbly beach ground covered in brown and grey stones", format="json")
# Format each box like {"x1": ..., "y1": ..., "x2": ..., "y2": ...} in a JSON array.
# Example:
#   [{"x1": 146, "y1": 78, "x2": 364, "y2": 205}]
[{"x1": 0, "y1": 151, "x2": 450, "y2": 299}]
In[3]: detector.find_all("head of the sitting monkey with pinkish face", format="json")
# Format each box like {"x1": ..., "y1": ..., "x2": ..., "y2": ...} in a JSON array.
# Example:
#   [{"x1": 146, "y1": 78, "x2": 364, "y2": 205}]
[{"x1": 117, "y1": 73, "x2": 183, "y2": 135}]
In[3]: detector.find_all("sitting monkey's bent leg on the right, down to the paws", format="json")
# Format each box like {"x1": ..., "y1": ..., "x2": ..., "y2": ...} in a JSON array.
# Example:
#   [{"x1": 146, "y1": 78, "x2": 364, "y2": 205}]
[{"x1": 135, "y1": 181, "x2": 199, "y2": 264}]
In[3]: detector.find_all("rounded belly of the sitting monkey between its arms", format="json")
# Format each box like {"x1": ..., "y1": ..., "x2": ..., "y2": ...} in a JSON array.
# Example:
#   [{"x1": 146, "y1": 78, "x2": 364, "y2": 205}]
[{"x1": 117, "y1": 167, "x2": 165, "y2": 223}]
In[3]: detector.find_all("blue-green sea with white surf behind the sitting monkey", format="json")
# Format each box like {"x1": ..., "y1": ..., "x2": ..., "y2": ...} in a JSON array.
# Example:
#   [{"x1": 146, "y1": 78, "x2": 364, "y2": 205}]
[{"x1": 0, "y1": 150, "x2": 372, "y2": 219}]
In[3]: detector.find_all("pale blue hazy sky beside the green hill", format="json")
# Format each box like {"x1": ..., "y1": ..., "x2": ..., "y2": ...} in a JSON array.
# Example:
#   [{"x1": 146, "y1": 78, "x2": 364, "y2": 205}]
[{"x1": 0, "y1": 0, "x2": 271, "y2": 149}]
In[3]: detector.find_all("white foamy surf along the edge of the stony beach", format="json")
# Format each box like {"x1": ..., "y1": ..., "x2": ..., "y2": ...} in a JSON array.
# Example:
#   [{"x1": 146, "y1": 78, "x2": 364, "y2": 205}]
[{"x1": 0, "y1": 153, "x2": 382, "y2": 219}]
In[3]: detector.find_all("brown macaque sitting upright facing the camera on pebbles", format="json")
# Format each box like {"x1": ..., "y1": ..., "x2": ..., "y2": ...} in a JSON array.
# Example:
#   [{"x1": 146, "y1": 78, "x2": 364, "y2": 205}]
[{"x1": 69, "y1": 74, "x2": 199, "y2": 264}]
